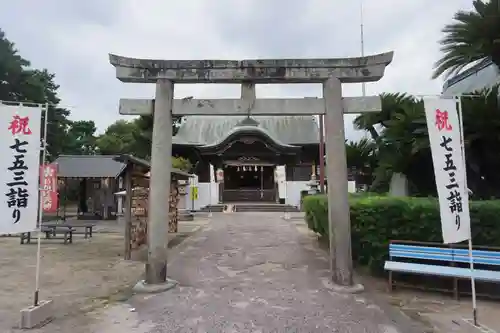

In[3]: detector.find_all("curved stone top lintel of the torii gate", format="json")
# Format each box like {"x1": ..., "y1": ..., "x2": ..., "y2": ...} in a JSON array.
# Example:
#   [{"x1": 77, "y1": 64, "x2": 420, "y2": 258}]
[{"x1": 109, "y1": 52, "x2": 394, "y2": 83}]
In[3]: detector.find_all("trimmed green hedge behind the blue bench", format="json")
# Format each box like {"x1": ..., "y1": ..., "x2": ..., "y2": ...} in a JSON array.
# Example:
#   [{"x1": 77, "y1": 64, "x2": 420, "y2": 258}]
[{"x1": 303, "y1": 194, "x2": 500, "y2": 274}]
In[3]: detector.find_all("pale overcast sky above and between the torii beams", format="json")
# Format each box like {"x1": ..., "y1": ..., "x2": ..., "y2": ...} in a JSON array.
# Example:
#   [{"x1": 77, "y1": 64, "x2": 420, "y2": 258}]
[{"x1": 0, "y1": 0, "x2": 472, "y2": 139}]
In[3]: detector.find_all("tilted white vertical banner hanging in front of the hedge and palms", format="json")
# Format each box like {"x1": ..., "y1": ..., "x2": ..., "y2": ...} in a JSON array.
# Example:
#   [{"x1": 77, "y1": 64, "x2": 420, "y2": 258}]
[{"x1": 424, "y1": 98, "x2": 471, "y2": 244}]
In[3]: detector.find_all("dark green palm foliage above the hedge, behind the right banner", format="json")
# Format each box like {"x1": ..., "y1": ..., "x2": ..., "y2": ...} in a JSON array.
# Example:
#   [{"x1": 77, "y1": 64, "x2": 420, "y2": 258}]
[{"x1": 358, "y1": 86, "x2": 500, "y2": 199}]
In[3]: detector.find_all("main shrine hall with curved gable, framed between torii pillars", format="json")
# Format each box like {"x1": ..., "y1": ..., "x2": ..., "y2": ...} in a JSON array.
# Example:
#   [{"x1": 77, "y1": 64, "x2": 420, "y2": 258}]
[{"x1": 172, "y1": 116, "x2": 319, "y2": 209}]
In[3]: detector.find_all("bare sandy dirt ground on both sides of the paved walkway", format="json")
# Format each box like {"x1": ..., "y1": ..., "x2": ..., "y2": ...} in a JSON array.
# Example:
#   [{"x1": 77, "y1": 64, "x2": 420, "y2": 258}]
[{"x1": 0, "y1": 214, "x2": 500, "y2": 333}]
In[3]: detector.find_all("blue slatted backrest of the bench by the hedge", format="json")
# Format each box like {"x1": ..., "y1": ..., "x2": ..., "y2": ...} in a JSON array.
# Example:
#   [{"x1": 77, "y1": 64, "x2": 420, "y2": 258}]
[{"x1": 389, "y1": 243, "x2": 500, "y2": 266}]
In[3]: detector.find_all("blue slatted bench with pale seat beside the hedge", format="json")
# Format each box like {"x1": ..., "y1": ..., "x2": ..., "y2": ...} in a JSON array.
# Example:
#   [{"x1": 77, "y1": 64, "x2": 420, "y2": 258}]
[{"x1": 384, "y1": 241, "x2": 500, "y2": 298}]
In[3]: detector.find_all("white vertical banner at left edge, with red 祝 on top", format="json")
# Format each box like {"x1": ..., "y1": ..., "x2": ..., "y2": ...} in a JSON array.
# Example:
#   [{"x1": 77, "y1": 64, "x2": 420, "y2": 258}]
[{"x1": 0, "y1": 104, "x2": 42, "y2": 234}]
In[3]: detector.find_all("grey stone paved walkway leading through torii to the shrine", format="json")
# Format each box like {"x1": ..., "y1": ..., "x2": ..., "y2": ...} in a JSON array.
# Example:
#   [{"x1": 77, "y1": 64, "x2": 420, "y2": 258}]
[{"x1": 30, "y1": 213, "x2": 421, "y2": 333}]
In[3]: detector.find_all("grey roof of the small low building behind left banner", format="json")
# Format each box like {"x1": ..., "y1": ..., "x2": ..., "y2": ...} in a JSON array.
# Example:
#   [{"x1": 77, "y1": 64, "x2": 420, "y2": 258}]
[{"x1": 54, "y1": 155, "x2": 125, "y2": 178}]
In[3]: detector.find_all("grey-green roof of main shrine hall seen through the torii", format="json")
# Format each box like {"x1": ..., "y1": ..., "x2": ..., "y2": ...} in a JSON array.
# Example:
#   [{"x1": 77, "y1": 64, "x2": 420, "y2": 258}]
[{"x1": 173, "y1": 116, "x2": 319, "y2": 146}]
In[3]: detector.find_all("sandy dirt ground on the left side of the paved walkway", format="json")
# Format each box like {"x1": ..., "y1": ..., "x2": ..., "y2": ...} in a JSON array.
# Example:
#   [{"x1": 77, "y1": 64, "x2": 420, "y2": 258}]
[{"x1": 0, "y1": 221, "x2": 208, "y2": 332}]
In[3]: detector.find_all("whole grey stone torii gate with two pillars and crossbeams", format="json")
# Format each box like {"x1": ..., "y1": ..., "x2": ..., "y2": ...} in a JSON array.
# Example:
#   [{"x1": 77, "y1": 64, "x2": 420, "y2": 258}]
[{"x1": 109, "y1": 52, "x2": 393, "y2": 290}]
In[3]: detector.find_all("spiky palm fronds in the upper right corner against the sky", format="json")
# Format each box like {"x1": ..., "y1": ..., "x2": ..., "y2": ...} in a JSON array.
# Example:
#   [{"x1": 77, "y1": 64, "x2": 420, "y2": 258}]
[{"x1": 432, "y1": 0, "x2": 500, "y2": 79}]
